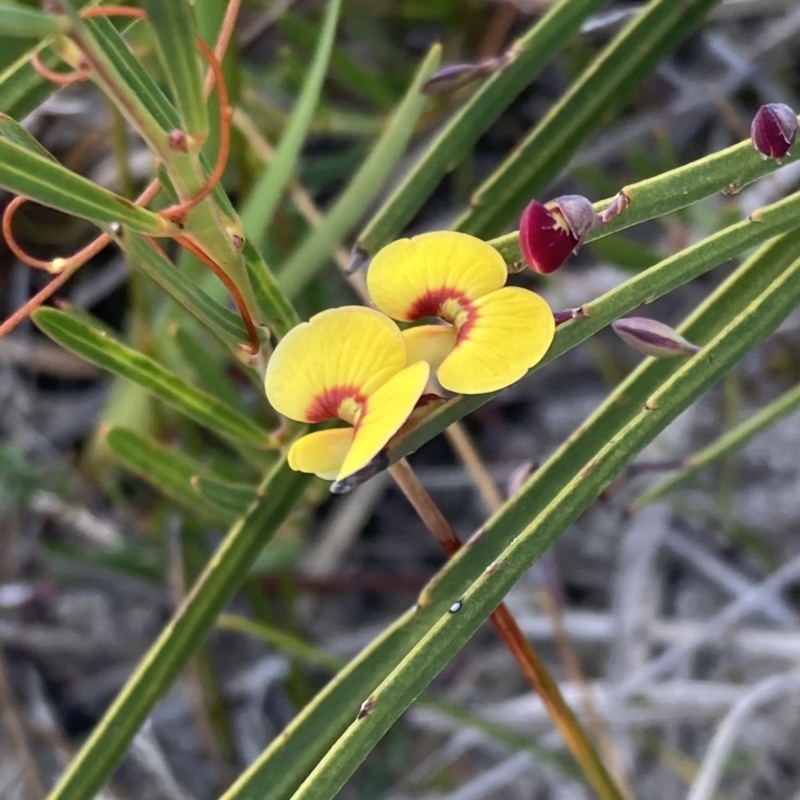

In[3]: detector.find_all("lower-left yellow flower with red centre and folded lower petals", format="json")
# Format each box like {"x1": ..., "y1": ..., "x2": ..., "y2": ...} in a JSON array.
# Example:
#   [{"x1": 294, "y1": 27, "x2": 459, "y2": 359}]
[{"x1": 264, "y1": 306, "x2": 430, "y2": 480}]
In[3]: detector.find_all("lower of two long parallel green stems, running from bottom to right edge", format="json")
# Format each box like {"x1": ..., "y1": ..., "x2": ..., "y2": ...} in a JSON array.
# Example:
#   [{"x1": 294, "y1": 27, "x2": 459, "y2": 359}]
[{"x1": 282, "y1": 238, "x2": 800, "y2": 800}]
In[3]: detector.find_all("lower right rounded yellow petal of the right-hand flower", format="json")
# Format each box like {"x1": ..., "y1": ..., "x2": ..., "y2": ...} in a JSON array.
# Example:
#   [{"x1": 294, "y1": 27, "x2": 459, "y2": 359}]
[{"x1": 437, "y1": 286, "x2": 555, "y2": 394}]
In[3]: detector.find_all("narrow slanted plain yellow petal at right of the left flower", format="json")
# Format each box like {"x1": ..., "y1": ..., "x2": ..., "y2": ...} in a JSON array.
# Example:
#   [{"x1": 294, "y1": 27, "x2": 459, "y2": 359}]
[{"x1": 337, "y1": 361, "x2": 430, "y2": 480}]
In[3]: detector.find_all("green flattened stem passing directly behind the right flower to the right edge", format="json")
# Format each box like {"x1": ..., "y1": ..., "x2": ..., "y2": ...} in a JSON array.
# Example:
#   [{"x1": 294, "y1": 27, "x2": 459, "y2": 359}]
[{"x1": 390, "y1": 189, "x2": 800, "y2": 460}]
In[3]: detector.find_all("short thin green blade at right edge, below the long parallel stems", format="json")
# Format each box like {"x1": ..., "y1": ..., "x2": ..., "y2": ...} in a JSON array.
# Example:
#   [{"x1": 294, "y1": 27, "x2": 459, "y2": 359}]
[{"x1": 630, "y1": 386, "x2": 800, "y2": 511}]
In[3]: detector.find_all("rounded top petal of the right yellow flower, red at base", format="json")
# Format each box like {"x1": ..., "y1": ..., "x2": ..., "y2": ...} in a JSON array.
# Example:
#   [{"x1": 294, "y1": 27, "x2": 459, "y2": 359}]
[{"x1": 367, "y1": 231, "x2": 508, "y2": 321}]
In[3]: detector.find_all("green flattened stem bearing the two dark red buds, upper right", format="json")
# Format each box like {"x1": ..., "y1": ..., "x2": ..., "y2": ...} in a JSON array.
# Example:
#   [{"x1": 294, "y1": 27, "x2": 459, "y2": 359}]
[{"x1": 490, "y1": 125, "x2": 800, "y2": 263}]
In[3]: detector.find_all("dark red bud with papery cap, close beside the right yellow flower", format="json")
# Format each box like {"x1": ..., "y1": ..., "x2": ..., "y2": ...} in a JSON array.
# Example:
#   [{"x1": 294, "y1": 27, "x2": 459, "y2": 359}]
[{"x1": 519, "y1": 194, "x2": 597, "y2": 275}]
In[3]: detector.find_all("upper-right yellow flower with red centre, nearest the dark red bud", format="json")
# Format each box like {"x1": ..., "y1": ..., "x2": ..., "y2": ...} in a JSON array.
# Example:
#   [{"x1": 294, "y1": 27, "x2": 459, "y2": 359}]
[{"x1": 367, "y1": 231, "x2": 555, "y2": 394}]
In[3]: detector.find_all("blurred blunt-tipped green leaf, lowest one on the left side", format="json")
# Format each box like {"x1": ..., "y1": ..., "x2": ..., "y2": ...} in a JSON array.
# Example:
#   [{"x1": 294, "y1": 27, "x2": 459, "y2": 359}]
[{"x1": 105, "y1": 428, "x2": 244, "y2": 525}]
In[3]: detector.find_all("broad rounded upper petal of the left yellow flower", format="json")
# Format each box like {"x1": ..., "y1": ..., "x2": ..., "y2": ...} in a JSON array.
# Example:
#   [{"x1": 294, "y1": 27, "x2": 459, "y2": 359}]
[{"x1": 264, "y1": 306, "x2": 406, "y2": 422}]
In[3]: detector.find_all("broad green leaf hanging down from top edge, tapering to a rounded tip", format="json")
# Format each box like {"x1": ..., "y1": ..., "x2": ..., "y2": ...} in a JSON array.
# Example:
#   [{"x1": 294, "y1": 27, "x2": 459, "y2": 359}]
[{"x1": 144, "y1": 0, "x2": 208, "y2": 141}]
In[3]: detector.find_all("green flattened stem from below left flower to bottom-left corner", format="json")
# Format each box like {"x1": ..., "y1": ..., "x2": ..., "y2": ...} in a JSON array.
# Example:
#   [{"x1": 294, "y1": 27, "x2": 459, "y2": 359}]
[{"x1": 43, "y1": 461, "x2": 309, "y2": 800}]
